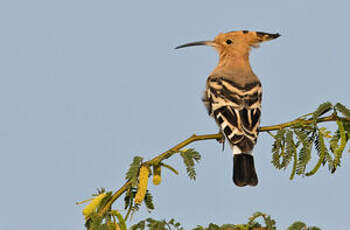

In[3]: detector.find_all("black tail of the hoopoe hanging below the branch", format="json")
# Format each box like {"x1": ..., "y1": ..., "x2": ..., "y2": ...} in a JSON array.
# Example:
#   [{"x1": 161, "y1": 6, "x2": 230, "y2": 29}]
[{"x1": 232, "y1": 153, "x2": 258, "y2": 187}]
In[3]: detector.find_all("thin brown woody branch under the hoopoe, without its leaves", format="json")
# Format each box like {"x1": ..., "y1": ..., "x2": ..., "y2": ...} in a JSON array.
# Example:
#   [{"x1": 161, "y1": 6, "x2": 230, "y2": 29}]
[{"x1": 98, "y1": 113, "x2": 350, "y2": 216}]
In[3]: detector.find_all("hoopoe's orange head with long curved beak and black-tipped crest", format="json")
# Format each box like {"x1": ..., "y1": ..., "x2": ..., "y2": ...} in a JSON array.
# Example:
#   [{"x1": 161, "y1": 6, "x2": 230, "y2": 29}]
[{"x1": 175, "y1": 30, "x2": 280, "y2": 56}]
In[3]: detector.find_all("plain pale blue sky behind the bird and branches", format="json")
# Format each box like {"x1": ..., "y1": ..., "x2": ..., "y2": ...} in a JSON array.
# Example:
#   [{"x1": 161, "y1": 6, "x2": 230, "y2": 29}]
[{"x1": 0, "y1": 0, "x2": 350, "y2": 230}]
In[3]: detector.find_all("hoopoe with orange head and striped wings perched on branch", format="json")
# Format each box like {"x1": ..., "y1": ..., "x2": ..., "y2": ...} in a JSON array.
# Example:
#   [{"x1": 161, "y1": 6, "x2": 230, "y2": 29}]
[{"x1": 176, "y1": 30, "x2": 280, "y2": 187}]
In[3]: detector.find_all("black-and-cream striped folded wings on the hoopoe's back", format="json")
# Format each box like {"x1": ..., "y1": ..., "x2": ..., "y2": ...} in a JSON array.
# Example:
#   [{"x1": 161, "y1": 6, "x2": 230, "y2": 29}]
[{"x1": 203, "y1": 77, "x2": 262, "y2": 154}]
